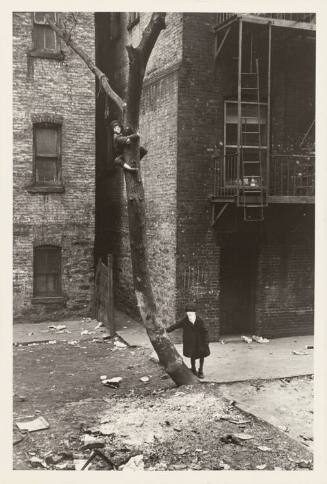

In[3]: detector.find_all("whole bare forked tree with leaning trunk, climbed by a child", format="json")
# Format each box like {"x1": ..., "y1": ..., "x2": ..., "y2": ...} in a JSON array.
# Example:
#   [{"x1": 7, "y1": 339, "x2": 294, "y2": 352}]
[{"x1": 47, "y1": 12, "x2": 199, "y2": 385}]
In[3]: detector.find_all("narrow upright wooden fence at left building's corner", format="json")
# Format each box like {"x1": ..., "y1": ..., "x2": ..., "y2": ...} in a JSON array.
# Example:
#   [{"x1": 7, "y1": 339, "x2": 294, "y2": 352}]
[{"x1": 95, "y1": 254, "x2": 116, "y2": 336}]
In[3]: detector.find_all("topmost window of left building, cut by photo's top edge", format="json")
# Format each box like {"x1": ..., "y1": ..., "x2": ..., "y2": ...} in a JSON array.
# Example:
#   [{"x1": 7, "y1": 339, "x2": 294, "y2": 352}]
[{"x1": 33, "y1": 12, "x2": 58, "y2": 52}]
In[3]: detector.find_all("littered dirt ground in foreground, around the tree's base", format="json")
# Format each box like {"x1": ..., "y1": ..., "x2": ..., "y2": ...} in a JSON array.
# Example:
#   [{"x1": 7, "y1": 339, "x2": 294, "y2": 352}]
[{"x1": 13, "y1": 339, "x2": 312, "y2": 470}]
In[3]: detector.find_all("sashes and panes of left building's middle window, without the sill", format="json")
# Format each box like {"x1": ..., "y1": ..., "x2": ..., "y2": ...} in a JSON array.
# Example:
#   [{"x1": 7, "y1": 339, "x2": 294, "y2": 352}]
[{"x1": 34, "y1": 125, "x2": 61, "y2": 185}]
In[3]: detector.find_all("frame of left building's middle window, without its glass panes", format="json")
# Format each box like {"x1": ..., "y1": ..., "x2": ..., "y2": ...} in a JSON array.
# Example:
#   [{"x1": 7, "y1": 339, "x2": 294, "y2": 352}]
[{"x1": 33, "y1": 122, "x2": 62, "y2": 189}]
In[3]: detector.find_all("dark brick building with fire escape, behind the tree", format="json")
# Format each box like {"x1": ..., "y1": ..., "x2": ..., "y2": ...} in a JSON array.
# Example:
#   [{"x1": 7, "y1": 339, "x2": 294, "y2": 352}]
[{"x1": 95, "y1": 12, "x2": 315, "y2": 340}]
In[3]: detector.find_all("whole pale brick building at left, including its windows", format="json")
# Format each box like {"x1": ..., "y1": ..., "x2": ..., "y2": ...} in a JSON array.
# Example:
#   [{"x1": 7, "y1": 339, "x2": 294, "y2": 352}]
[{"x1": 13, "y1": 12, "x2": 95, "y2": 320}]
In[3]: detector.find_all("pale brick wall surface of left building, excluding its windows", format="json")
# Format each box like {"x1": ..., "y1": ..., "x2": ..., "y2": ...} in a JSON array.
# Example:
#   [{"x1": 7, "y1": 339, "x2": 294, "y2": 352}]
[{"x1": 13, "y1": 12, "x2": 95, "y2": 319}]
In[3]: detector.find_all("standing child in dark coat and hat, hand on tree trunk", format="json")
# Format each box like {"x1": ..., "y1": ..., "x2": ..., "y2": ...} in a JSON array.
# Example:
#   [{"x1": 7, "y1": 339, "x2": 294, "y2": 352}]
[{"x1": 167, "y1": 303, "x2": 210, "y2": 378}]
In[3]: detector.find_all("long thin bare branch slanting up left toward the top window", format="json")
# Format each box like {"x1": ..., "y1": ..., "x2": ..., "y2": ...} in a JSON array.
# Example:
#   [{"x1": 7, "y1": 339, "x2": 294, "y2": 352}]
[{"x1": 46, "y1": 15, "x2": 126, "y2": 113}]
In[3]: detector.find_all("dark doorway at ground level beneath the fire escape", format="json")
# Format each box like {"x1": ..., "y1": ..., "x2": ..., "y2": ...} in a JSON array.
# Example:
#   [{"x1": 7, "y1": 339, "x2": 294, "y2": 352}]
[{"x1": 220, "y1": 244, "x2": 258, "y2": 335}]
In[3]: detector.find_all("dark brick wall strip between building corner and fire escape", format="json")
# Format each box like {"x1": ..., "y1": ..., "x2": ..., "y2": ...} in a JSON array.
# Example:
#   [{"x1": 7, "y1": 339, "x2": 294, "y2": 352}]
[{"x1": 176, "y1": 13, "x2": 220, "y2": 339}]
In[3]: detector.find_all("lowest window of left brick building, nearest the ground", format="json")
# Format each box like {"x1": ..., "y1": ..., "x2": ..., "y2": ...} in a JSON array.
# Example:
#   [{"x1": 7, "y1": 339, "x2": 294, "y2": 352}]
[{"x1": 34, "y1": 245, "x2": 61, "y2": 297}]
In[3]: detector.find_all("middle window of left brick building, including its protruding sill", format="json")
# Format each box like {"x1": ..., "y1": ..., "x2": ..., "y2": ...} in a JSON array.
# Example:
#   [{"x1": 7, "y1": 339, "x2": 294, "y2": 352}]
[{"x1": 29, "y1": 123, "x2": 64, "y2": 193}]
